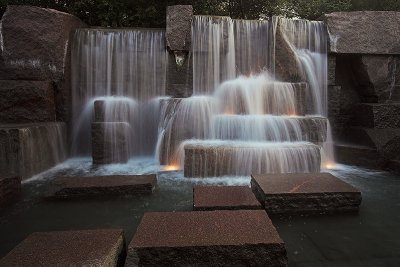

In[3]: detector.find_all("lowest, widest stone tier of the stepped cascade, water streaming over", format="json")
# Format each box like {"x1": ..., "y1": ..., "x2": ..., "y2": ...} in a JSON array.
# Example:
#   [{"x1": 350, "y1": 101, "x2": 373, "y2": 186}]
[{"x1": 181, "y1": 140, "x2": 321, "y2": 177}]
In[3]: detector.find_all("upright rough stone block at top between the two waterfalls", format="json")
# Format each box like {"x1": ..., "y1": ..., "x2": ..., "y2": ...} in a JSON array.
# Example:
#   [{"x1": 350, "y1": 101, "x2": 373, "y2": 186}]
[{"x1": 166, "y1": 5, "x2": 193, "y2": 51}]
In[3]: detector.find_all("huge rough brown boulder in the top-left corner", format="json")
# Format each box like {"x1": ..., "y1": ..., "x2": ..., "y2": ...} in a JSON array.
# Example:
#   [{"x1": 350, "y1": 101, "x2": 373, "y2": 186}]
[{"x1": 0, "y1": 5, "x2": 85, "y2": 80}]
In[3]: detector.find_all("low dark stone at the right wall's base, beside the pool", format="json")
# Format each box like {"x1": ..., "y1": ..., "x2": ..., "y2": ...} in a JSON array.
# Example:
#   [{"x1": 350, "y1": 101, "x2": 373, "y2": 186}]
[{"x1": 335, "y1": 144, "x2": 385, "y2": 169}]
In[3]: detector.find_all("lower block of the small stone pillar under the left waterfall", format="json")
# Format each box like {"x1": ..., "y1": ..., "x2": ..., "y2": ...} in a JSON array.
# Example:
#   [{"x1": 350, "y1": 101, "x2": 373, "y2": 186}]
[{"x1": 92, "y1": 122, "x2": 131, "y2": 164}]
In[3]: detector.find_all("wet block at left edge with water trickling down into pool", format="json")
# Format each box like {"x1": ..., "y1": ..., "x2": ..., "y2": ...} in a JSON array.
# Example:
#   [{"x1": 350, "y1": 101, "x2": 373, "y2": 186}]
[{"x1": 0, "y1": 122, "x2": 67, "y2": 179}]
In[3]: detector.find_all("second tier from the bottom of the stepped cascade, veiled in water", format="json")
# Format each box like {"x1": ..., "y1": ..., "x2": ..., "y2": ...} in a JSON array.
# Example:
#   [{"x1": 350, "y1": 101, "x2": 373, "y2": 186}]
[{"x1": 211, "y1": 115, "x2": 328, "y2": 143}]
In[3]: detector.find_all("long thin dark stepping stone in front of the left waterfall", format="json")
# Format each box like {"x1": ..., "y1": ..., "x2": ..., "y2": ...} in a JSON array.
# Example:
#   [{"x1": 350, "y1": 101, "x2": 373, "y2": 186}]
[{"x1": 49, "y1": 174, "x2": 157, "y2": 199}]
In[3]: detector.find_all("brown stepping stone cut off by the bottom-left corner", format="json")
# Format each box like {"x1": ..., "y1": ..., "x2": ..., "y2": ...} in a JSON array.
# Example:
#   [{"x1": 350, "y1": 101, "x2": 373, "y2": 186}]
[{"x1": 0, "y1": 229, "x2": 126, "y2": 267}]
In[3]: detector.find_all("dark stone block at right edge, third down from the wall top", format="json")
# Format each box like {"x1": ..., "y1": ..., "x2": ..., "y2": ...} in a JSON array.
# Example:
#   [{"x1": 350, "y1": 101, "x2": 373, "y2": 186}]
[{"x1": 353, "y1": 103, "x2": 400, "y2": 129}]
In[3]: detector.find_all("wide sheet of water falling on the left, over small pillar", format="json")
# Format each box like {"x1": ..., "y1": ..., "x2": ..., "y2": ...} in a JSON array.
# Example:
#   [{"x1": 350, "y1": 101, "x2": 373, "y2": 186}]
[{"x1": 72, "y1": 29, "x2": 166, "y2": 156}]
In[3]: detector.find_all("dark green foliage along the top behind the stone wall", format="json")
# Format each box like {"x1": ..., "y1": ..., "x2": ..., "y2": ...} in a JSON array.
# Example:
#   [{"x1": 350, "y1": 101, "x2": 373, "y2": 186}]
[{"x1": 0, "y1": 0, "x2": 400, "y2": 27}]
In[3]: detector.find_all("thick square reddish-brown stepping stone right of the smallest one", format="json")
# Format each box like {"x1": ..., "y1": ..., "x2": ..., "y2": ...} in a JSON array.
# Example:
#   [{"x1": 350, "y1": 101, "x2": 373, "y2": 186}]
[{"x1": 251, "y1": 173, "x2": 361, "y2": 214}]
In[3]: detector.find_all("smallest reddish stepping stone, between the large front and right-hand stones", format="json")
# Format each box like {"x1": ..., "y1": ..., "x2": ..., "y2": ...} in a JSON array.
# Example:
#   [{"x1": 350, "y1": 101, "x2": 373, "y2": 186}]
[{"x1": 193, "y1": 186, "x2": 263, "y2": 210}]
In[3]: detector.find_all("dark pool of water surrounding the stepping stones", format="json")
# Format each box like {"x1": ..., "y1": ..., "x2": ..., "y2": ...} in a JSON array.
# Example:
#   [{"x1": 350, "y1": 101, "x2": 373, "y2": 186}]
[{"x1": 0, "y1": 158, "x2": 400, "y2": 266}]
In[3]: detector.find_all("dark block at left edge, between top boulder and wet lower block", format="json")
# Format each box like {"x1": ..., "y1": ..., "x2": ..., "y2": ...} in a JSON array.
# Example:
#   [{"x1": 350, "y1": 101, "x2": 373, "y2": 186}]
[{"x1": 0, "y1": 80, "x2": 56, "y2": 123}]
